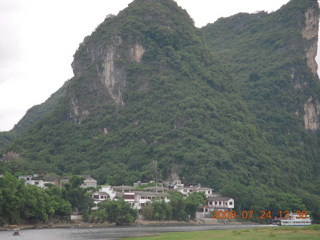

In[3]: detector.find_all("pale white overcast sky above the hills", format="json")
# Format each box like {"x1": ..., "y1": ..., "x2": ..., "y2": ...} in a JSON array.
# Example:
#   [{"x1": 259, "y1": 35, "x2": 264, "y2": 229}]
[{"x1": 0, "y1": 0, "x2": 312, "y2": 131}]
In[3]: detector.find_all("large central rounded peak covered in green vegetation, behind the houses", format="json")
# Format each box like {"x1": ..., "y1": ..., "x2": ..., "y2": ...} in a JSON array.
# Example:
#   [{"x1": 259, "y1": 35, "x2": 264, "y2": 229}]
[{"x1": 0, "y1": 0, "x2": 317, "y2": 218}]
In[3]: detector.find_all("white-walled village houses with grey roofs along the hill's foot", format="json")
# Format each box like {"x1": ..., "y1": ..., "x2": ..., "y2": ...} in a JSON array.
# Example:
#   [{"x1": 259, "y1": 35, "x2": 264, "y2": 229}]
[{"x1": 15, "y1": 174, "x2": 234, "y2": 214}]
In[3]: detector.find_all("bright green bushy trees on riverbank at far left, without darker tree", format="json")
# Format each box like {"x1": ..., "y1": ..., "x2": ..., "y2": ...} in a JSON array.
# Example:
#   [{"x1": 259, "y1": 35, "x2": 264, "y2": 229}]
[{"x1": 0, "y1": 173, "x2": 71, "y2": 226}]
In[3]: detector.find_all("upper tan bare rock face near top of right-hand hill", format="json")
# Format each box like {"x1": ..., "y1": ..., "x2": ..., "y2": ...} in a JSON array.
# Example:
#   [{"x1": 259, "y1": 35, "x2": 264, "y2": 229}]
[{"x1": 302, "y1": 8, "x2": 319, "y2": 74}]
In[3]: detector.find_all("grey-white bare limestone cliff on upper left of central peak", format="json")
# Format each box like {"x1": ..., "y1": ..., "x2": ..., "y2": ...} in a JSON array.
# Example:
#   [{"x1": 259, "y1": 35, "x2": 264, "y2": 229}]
[{"x1": 69, "y1": 22, "x2": 144, "y2": 124}]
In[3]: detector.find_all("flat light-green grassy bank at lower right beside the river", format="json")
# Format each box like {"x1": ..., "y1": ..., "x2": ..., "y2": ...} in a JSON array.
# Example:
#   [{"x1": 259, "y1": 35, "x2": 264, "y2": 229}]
[{"x1": 122, "y1": 226, "x2": 320, "y2": 240}]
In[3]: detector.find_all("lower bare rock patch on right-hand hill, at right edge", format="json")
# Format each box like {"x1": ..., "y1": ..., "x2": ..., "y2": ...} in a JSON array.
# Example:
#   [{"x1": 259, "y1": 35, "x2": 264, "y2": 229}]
[{"x1": 304, "y1": 97, "x2": 320, "y2": 131}]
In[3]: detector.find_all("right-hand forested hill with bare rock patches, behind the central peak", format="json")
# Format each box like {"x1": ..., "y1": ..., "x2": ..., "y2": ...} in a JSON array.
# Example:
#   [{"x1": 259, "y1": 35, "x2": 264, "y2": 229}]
[{"x1": 202, "y1": 0, "x2": 320, "y2": 216}]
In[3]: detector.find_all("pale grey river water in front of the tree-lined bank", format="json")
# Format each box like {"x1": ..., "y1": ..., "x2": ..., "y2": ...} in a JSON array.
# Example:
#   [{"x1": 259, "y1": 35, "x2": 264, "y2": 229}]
[{"x1": 0, "y1": 225, "x2": 271, "y2": 240}]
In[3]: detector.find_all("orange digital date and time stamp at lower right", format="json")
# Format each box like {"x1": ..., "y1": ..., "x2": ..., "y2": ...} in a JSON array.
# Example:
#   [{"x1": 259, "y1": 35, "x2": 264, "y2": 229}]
[{"x1": 212, "y1": 210, "x2": 308, "y2": 220}]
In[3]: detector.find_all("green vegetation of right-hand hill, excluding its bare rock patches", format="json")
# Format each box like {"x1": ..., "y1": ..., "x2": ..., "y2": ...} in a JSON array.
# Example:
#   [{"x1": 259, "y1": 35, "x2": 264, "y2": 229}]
[{"x1": 202, "y1": 0, "x2": 320, "y2": 219}]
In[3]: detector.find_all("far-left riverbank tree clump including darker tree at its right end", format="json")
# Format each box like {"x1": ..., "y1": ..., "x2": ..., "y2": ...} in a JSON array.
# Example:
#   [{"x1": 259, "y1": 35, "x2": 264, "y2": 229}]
[{"x1": 0, "y1": 173, "x2": 93, "y2": 226}]
